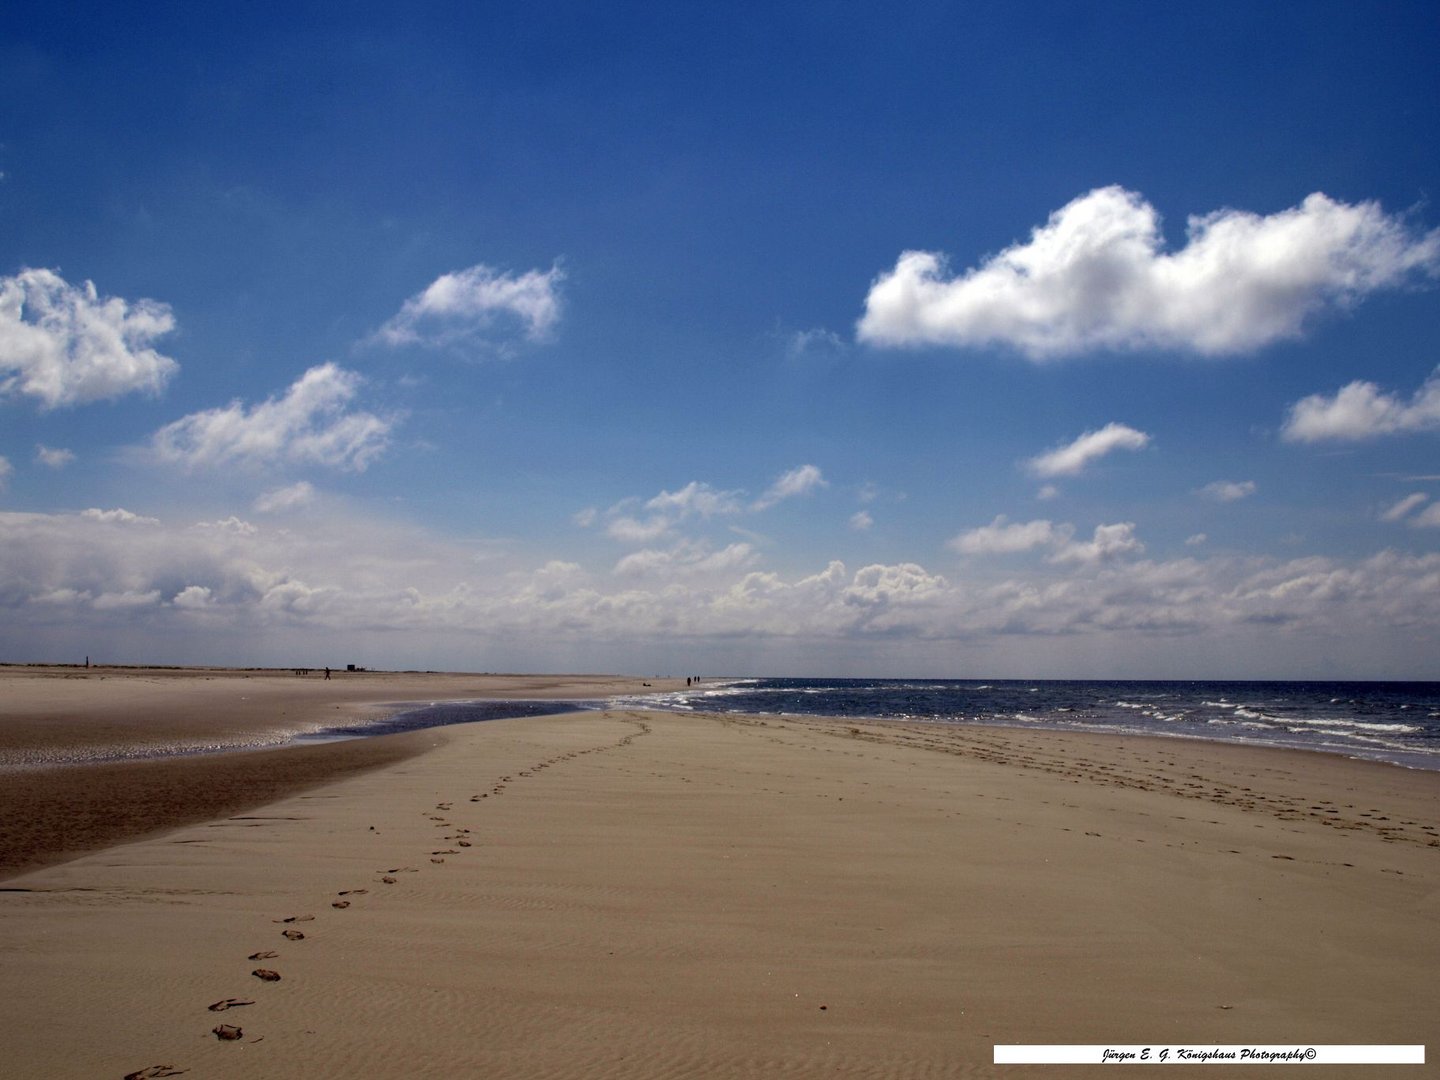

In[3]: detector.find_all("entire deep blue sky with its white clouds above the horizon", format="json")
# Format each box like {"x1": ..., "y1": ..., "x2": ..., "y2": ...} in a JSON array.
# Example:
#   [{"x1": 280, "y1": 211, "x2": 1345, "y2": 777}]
[{"x1": 0, "y1": 3, "x2": 1440, "y2": 678}]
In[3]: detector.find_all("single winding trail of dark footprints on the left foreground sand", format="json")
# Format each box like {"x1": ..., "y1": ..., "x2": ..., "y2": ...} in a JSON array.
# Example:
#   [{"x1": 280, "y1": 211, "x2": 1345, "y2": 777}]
[{"x1": 124, "y1": 716, "x2": 651, "y2": 1080}]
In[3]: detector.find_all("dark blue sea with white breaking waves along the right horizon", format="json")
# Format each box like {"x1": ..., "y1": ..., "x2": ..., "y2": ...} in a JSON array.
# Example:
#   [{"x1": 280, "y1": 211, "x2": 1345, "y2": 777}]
[{"x1": 611, "y1": 678, "x2": 1440, "y2": 770}]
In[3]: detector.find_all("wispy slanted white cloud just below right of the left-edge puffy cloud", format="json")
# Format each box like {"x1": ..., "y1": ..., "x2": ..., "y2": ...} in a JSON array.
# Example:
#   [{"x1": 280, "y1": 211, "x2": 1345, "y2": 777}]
[{"x1": 151, "y1": 363, "x2": 393, "y2": 471}]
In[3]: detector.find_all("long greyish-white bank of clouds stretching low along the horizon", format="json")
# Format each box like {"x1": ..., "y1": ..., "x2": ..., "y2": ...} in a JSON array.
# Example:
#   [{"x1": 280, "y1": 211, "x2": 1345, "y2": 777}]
[{"x1": 8, "y1": 511, "x2": 1440, "y2": 677}]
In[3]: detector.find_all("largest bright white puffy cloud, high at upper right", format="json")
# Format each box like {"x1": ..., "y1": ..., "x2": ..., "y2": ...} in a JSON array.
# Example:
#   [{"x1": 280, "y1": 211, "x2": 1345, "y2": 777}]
[{"x1": 857, "y1": 186, "x2": 1440, "y2": 360}]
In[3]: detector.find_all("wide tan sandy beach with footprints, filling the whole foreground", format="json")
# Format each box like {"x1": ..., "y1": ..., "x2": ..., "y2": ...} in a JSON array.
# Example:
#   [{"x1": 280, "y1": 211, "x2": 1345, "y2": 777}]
[{"x1": 0, "y1": 670, "x2": 1440, "y2": 1080}]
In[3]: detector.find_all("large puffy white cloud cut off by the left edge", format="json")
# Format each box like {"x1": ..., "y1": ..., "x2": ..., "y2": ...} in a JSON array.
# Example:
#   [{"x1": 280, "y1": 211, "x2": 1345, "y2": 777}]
[{"x1": 0, "y1": 269, "x2": 180, "y2": 409}]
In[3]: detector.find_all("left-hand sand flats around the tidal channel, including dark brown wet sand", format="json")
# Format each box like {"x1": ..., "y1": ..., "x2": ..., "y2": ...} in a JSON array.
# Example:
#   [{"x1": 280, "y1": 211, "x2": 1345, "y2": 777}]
[{"x1": 0, "y1": 665, "x2": 683, "y2": 881}]
